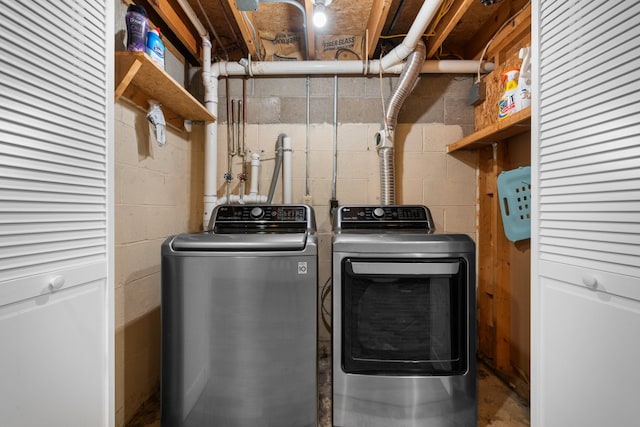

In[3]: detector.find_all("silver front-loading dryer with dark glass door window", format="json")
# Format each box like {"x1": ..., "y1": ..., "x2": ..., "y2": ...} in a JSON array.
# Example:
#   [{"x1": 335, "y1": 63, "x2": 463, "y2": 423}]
[{"x1": 332, "y1": 205, "x2": 477, "y2": 427}]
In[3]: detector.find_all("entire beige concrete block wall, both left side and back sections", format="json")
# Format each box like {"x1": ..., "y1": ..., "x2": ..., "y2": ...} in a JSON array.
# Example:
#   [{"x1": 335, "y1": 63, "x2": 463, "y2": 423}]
[{"x1": 115, "y1": 69, "x2": 476, "y2": 426}]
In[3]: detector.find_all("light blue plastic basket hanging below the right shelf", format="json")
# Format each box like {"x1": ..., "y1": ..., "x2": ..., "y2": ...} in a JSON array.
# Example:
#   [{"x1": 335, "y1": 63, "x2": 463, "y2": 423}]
[{"x1": 498, "y1": 166, "x2": 531, "y2": 242}]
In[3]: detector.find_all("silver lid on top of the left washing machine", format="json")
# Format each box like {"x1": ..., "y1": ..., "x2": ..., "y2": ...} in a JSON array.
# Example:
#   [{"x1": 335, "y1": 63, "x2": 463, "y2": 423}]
[{"x1": 171, "y1": 232, "x2": 307, "y2": 252}]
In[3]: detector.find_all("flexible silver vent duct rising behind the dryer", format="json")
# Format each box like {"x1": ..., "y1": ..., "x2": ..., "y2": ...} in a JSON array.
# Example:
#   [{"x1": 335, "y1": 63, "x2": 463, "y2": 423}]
[{"x1": 376, "y1": 41, "x2": 427, "y2": 205}]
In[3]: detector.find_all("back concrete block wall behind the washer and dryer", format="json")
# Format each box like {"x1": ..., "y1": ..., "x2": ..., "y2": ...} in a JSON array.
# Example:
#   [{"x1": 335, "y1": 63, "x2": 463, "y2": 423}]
[{"x1": 218, "y1": 75, "x2": 477, "y2": 339}]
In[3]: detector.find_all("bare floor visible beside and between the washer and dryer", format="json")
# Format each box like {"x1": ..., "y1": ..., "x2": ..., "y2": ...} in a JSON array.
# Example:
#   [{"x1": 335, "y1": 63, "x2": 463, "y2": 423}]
[{"x1": 127, "y1": 342, "x2": 530, "y2": 427}]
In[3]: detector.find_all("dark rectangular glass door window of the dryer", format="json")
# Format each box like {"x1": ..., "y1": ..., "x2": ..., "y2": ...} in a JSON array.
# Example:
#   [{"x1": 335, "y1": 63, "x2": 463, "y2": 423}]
[{"x1": 341, "y1": 258, "x2": 468, "y2": 375}]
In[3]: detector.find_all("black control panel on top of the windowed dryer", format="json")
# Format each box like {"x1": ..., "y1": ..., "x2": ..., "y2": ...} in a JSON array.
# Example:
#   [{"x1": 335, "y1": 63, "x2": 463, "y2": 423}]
[{"x1": 335, "y1": 205, "x2": 435, "y2": 230}]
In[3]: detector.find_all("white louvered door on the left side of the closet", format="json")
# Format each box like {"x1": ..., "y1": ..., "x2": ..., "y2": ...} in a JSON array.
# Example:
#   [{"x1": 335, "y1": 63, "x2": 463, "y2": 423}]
[{"x1": 0, "y1": 0, "x2": 113, "y2": 426}]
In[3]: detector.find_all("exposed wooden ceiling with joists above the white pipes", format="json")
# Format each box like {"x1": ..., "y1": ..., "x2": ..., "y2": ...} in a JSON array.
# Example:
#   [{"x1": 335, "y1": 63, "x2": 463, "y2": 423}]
[{"x1": 152, "y1": 0, "x2": 528, "y2": 67}]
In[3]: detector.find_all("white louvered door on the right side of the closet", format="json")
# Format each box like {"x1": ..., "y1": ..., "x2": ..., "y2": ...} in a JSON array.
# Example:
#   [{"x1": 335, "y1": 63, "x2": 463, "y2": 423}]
[{"x1": 532, "y1": 0, "x2": 640, "y2": 427}]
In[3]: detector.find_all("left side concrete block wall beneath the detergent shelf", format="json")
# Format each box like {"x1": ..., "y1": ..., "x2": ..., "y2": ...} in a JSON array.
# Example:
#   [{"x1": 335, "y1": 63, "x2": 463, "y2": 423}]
[{"x1": 115, "y1": 102, "x2": 203, "y2": 426}]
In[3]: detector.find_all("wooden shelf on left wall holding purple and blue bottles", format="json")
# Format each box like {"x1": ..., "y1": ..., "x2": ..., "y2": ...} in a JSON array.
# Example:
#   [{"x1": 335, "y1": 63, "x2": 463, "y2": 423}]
[{"x1": 115, "y1": 52, "x2": 216, "y2": 130}]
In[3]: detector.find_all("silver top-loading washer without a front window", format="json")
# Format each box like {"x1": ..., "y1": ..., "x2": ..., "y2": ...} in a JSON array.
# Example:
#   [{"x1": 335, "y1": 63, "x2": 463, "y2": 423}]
[{"x1": 161, "y1": 205, "x2": 318, "y2": 427}]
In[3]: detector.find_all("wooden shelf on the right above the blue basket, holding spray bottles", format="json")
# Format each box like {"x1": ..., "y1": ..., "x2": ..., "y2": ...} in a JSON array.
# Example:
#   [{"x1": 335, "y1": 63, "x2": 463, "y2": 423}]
[{"x1": 447, "y1": 107, "x2": 531, "y2": 153}]
